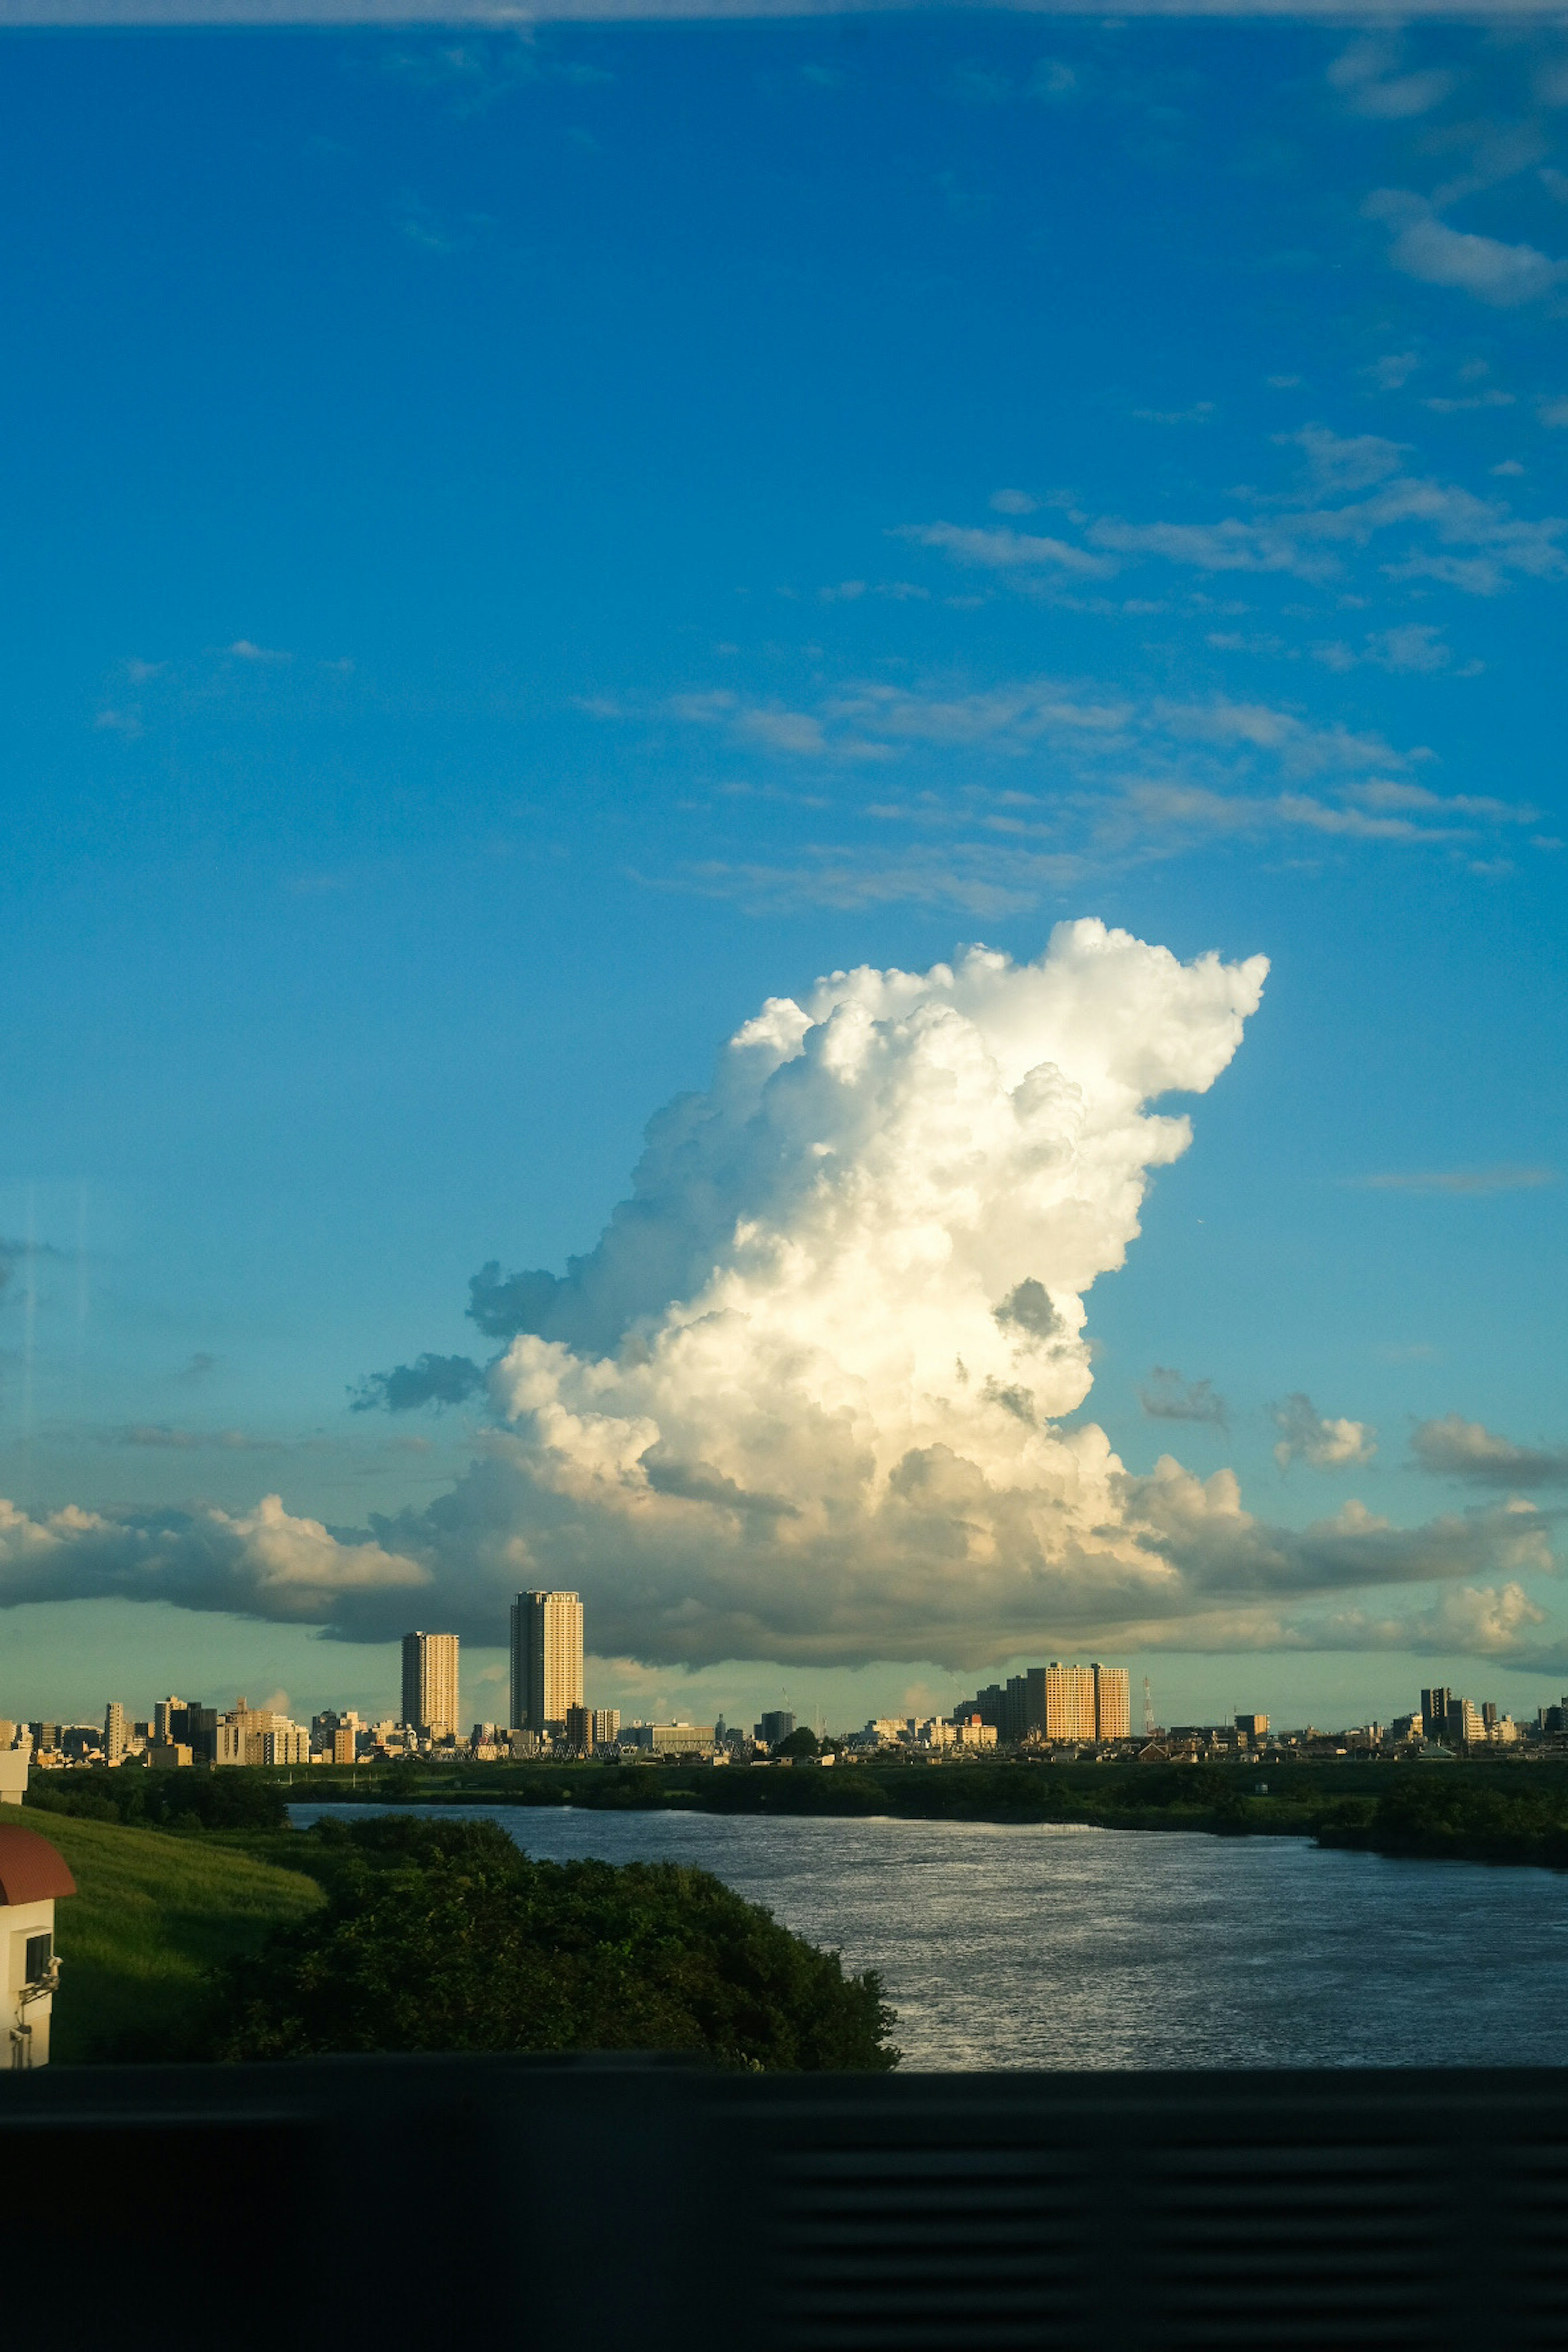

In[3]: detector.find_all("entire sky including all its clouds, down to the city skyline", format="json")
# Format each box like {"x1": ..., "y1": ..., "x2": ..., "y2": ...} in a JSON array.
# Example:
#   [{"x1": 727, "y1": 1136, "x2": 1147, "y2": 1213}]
[{"x1": 0, "y1": 12, "x2": 1568, "y2": 1722}]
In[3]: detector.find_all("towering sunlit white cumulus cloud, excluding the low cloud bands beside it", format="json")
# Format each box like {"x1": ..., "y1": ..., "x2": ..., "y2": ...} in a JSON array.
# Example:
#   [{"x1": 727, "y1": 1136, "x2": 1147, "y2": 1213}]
[{"x1": 435, "y1": 922, "x2": 1267, "y2": 1663}]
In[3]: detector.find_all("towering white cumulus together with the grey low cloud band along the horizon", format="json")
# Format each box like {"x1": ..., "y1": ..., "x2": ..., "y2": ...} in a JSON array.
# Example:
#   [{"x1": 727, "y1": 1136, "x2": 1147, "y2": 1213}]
[{"x1": 0, "y1": 922, "x2": 1552, "y2": 1672}]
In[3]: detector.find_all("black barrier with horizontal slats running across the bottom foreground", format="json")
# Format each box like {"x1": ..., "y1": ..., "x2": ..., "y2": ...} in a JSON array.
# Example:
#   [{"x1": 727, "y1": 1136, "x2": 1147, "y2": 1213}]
[{"x1": 0, "y1": 2058, "x2": 1568, "y2": 2352}]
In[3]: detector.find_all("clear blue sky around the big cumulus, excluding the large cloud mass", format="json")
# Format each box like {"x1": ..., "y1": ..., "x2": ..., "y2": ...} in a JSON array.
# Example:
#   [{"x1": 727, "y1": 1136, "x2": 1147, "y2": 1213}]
[{"x1": 0, "y1": 14, "x2": 1568, "y2": 1719}]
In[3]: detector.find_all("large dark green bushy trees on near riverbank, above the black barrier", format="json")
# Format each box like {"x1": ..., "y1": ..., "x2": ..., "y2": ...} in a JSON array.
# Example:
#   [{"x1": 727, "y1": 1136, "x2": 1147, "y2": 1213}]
[{"x1": 195, "y1": 1816, "x2": 898, "y2": 2070}]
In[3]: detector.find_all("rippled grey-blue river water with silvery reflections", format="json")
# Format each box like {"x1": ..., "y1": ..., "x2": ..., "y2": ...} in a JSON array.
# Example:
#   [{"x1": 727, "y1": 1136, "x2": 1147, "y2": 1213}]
[{"x1": 292, "y1": 1804, "x2": 1568, "y2": 2067}]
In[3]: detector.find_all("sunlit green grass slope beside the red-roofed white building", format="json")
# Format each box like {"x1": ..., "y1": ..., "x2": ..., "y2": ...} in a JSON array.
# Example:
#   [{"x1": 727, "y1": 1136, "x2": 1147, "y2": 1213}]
[{"x1": 9, "y1": 1809, "x2": 322, "y2": 2065}]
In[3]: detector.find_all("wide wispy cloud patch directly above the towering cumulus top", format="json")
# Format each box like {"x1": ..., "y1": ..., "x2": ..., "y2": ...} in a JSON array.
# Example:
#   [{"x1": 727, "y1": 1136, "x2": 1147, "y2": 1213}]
[{"x1": 595, "y1": 677, "x2": 1537, "y2": 915}]
